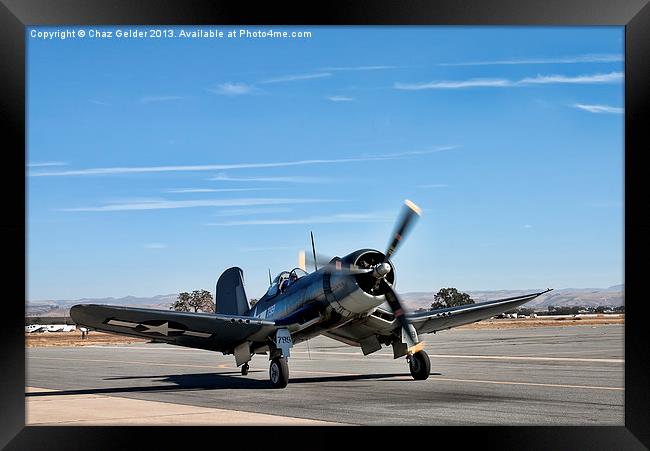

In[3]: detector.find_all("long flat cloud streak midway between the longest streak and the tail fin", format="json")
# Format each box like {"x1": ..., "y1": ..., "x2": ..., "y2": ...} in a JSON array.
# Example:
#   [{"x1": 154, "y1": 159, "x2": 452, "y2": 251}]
[{"x1": 60, "y1": 198, "x2": 342, "y2": 211}]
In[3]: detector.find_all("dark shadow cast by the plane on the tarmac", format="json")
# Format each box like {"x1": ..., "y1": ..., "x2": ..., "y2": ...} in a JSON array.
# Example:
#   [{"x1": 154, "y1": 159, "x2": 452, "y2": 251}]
[{"x1": 25, "y1": 370, "x2": 439, "y2": 396}]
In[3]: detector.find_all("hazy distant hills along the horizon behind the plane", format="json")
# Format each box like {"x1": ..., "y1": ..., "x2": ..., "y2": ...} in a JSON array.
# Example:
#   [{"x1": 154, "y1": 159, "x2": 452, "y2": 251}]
[{"x1": 25, "y1": 285, "x2": 625, "y2": 316}]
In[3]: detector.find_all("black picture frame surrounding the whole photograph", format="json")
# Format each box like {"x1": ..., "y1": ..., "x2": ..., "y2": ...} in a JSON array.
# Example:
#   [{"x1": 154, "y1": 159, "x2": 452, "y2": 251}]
[{"x1": 0, "y1": 0, "x2": 650, "y2": 450}]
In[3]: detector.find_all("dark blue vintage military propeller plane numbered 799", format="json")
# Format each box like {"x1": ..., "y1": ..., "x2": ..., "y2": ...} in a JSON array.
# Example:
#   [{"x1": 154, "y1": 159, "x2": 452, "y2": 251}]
[{"x1": 70, "y1": 200, "x2": 550, "y2": 388}]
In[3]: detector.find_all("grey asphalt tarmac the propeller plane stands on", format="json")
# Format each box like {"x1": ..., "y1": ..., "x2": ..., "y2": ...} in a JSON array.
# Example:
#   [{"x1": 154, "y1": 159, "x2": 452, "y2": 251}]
[{"x1": 26, "y1": 325, "x2": 624, "y2": 426}]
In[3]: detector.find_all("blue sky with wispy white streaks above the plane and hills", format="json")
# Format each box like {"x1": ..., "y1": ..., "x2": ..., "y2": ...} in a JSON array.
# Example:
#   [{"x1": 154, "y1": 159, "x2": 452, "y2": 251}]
[{"x1": 26, "y1": 27, "x2": 624, "y2": 300}]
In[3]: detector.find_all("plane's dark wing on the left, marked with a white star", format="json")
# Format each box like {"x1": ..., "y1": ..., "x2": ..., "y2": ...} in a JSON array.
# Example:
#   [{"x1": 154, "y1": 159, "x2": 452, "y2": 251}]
[{"x1": 70, "y1": 304, "x2": 276, "y2": 352}]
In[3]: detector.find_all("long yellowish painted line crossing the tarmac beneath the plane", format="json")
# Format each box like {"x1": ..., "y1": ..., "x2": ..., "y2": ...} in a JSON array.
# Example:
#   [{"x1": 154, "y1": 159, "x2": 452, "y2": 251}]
[{"x1": 32, "y1": 357, "x2": 625, "y2": 391}]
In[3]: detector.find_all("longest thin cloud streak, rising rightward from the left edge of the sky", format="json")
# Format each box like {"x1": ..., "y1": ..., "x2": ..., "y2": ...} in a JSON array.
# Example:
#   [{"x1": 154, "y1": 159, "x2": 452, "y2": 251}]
[{"x1": 29, "y1": 146, "x2": 457, "y2": 181}]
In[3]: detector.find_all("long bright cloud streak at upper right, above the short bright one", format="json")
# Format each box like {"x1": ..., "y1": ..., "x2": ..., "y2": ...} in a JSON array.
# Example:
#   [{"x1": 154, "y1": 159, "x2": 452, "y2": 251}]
[{"x1": 394, "y1": 72, "x2": 624, "y2": 91}]
